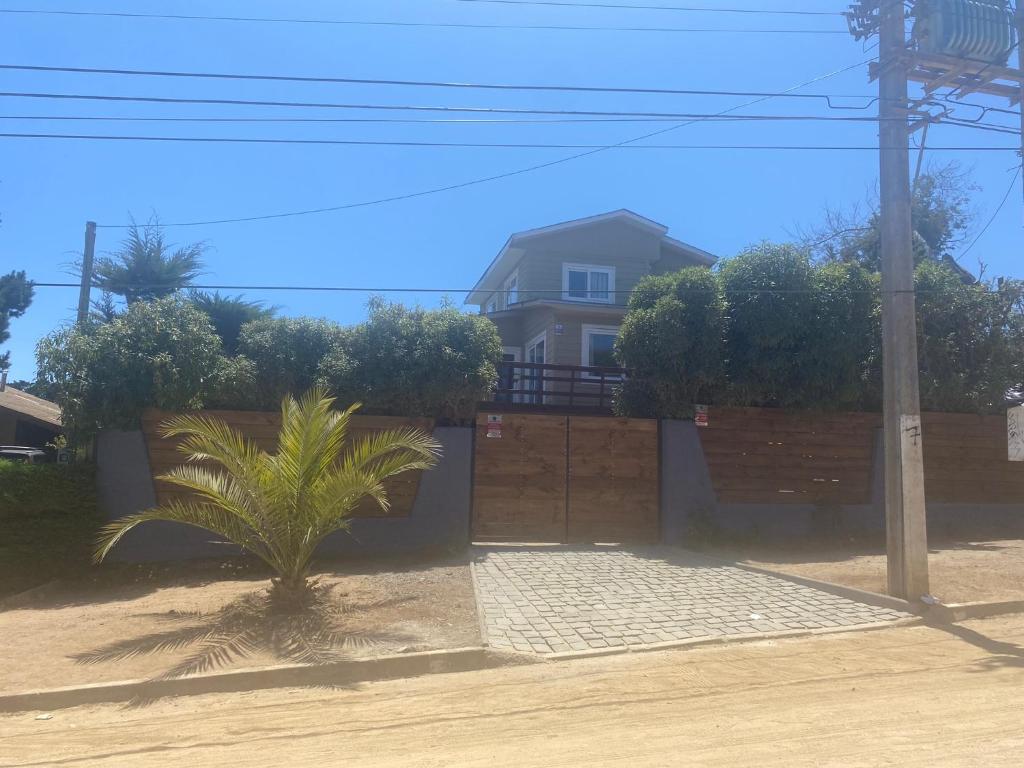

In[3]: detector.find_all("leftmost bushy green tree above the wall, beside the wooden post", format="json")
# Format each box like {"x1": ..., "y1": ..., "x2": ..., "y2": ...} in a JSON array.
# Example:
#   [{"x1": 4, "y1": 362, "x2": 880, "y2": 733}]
[{"x1": 36, "y1": 297, "x2": 223, "y2": 436}]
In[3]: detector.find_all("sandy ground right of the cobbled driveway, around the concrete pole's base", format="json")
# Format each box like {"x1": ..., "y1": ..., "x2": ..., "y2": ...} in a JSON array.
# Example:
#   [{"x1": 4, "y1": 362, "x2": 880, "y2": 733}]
[{"x1": 707, "y1": 539, "x2": 1024, "y2": 603}]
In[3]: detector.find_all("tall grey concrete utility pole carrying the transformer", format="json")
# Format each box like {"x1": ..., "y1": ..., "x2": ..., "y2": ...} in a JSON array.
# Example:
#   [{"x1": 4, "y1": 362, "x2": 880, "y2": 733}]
[{"x1": 879, "y1": 0, "x2": 929, "y2": 600}]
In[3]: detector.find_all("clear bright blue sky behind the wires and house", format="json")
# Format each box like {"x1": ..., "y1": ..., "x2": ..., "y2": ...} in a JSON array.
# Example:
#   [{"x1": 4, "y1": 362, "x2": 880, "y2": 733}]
[{"x1": 0, "y1": 0, "x2": 1024, "y2": 378}]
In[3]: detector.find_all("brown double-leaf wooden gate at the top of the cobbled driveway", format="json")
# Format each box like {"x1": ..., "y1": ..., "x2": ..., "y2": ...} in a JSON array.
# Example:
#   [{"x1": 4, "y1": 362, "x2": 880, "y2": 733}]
[{"x1": 473, "y1": 413, "x2": 659, "y2": 544}]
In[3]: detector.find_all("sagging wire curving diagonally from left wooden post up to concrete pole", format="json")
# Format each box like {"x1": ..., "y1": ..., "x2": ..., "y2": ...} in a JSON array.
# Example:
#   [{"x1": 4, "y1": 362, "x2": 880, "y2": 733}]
[{"x1": 83, "y1": 59, "x2": 873, "y2": 229}]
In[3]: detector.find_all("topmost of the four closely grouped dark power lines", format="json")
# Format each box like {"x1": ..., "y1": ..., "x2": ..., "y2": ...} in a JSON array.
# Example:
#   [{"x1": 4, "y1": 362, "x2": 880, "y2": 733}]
[{"x1": 0, "y1": 63, "x2": 877, "y2": 101}]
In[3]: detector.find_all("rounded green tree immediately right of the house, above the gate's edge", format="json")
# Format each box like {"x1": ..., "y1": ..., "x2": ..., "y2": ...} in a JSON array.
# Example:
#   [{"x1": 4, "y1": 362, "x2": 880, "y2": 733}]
[{"x1": 615, "y1": 267, "x2": 725, "y2": 418}]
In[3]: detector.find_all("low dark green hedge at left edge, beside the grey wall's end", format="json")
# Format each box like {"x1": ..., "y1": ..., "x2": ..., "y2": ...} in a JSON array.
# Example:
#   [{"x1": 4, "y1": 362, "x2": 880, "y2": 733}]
[{"x1": 0, "y1": 461, "x2": 99, "y2": 596}]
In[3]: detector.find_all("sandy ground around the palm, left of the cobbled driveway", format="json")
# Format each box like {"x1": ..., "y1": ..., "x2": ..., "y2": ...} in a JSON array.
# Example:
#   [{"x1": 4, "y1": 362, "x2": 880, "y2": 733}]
[{"x1": 0, "y1": 559, "x2": 480, "y2": 691}]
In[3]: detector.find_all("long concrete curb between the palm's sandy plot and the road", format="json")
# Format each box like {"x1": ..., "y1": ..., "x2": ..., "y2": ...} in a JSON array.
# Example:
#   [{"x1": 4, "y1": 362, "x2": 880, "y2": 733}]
[{"x1": 0, "y1": 647, "x2": 540, "y2": 713}]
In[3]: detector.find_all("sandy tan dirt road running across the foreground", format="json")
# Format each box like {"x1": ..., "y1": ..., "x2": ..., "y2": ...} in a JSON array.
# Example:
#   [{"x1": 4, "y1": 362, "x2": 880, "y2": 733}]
[{"x1": 0, "y1": 615, "x2": 1024, "y2": 768}]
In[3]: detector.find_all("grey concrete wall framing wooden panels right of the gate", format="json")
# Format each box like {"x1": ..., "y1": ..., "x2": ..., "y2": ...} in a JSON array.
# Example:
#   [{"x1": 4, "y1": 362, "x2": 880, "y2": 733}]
[{"x1": 660, "y1": 420, "x2": 1024, "y2": 546}]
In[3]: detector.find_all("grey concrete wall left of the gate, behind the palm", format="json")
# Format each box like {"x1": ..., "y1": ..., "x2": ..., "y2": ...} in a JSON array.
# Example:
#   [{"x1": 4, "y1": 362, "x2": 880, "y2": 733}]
[{"x1": 96, "y1": 427, "x2": 473, "y2": 562}]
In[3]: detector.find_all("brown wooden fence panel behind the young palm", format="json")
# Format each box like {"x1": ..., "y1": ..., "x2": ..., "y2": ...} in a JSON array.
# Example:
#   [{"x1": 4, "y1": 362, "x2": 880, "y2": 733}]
[{"x1": 141, "y1": 409, "x2": 433, "y2": 517}]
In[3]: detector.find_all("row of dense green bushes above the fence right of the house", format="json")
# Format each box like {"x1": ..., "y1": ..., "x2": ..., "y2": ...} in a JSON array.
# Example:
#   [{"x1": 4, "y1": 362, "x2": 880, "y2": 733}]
[{"x1": 616, "y1": 244, "x2": 1024, "y2": 418}]
